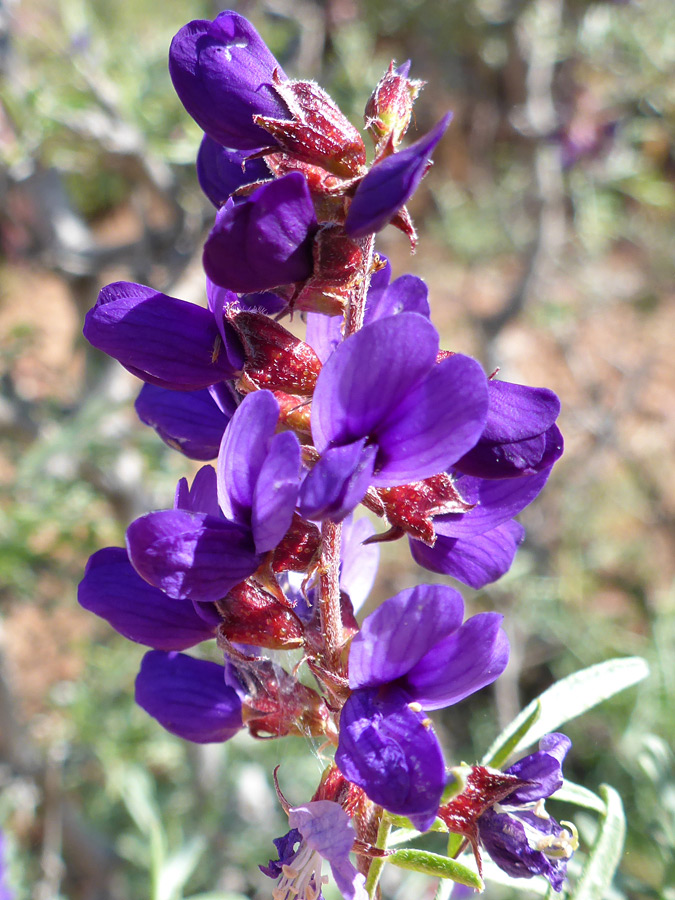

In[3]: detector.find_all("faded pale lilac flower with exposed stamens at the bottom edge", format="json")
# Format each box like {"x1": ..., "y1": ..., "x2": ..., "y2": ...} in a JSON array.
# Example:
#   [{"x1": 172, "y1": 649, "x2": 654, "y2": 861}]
[{"x1": 260, "y1": 800, "x2": 368, "y2": 900}]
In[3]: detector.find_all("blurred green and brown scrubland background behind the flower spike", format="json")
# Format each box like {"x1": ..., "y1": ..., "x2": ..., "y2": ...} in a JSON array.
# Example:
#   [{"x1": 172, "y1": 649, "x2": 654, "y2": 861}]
[{"x1": 0, "y1": 0, "x2": 675, "y2": 900}]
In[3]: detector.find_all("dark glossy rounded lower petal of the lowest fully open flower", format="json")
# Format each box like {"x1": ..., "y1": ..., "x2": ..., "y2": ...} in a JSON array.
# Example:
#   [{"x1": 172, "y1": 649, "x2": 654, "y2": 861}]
[{"x1": 335, "y1": 688, "x2": 445, "y2": 831}]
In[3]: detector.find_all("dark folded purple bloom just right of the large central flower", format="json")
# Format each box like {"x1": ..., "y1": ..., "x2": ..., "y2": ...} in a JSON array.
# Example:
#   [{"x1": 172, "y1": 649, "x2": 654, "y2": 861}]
[{"x1": 454, "y1": 380, "x2": 563, "y2": 478}]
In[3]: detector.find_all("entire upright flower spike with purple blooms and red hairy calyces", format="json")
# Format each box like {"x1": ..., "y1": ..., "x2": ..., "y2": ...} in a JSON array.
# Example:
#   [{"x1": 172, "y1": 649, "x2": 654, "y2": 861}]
[{"x1": 79, "y1": 12, "x2": 641, "y2": 900}]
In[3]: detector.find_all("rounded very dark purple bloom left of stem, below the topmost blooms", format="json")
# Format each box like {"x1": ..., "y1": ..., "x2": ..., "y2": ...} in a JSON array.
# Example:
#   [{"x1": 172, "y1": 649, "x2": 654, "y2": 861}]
[{"x1": 204, "y1": 172, "x2": 317, "y2": 294}]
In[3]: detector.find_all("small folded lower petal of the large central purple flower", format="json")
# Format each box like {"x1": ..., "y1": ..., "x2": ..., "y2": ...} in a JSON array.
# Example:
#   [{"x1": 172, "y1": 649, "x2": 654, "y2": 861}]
[{"x1": 298, "y1": 438, "x2": 377, "y2": 522}]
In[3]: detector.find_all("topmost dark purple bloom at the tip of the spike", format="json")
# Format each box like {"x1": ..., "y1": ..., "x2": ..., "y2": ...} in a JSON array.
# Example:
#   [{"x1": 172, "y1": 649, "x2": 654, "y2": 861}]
[{"x1": 169, "y1": 11, "x2": 289, "y2": 150}]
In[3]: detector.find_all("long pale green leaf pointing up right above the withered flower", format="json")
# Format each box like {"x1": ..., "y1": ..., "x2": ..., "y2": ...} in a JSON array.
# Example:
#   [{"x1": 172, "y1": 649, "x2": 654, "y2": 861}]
[{"x1": 487, "y1": 656, "x2": 649, "y2": 757}]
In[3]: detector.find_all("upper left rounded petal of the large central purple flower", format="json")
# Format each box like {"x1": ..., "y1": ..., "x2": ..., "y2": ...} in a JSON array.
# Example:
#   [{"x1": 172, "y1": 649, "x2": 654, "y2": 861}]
[{"x1": 312, "y1": 313, "x2": 439, "y2": 453}]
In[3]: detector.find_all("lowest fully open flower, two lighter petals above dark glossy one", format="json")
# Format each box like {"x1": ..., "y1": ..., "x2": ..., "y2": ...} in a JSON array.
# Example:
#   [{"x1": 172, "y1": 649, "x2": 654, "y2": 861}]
[{"x1": 335, "y1": 585, "x2": 508, "y2": 830}]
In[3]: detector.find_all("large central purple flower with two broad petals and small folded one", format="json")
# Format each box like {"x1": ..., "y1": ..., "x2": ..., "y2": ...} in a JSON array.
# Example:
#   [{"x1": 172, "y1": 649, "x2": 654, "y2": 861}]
[{"x1": 300, "y1": 313, "x2": 487, "y2": 521}]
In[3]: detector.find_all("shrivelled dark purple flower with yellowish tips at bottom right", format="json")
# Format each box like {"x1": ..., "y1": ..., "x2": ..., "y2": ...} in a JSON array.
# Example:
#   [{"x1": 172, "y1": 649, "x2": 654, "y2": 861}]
[{"x1": 478, "y1": 734, "x2": 578, "y2": 891}]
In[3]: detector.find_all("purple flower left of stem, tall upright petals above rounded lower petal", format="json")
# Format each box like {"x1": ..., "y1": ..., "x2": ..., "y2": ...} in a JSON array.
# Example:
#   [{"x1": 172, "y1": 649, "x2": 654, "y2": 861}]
[{"x1": 127, "y1": 391, "x2": 300, "y2": 603}]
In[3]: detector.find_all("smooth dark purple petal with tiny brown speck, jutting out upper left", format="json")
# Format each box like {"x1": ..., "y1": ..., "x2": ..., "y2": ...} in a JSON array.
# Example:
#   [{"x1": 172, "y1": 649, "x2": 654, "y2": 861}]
[{"x1": 83, "y1": 281, "x2": 234, "y2": 391}]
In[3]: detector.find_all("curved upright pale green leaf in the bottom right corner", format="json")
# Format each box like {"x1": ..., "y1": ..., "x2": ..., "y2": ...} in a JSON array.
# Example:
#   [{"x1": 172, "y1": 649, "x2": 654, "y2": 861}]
[{"x1": 570, "y1": 784, "x2": 626, "y2": 900}]
